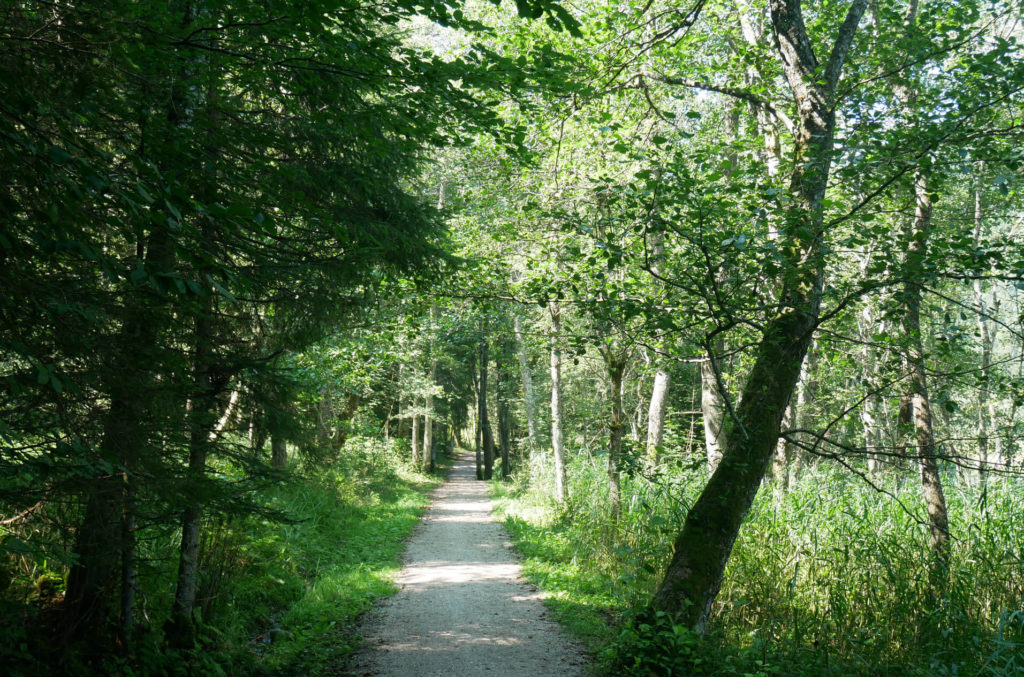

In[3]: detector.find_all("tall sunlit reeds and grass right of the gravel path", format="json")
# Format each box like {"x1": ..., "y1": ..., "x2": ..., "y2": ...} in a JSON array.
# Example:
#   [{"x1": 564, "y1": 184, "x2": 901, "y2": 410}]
[{"x1": 495, "y1": 457, "x2": 1024, "y2": 677}]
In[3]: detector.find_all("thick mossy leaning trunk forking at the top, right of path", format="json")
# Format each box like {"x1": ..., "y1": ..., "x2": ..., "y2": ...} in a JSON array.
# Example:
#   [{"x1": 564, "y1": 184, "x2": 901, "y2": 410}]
[{"x1": 653, "y1": 0, "x2": 867, "y2": 632}]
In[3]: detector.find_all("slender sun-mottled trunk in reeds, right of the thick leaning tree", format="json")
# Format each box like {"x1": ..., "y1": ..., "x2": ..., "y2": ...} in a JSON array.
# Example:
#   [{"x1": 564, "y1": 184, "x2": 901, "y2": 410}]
[{"x1": 903, "y1": 171, "x2": 949, "y2": 586}]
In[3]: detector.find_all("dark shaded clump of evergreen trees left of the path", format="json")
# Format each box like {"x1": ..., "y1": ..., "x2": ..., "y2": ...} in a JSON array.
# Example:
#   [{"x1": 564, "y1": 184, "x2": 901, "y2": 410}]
[{"x1": 0, "y1": 2, "x2": 507, "y2": 652}]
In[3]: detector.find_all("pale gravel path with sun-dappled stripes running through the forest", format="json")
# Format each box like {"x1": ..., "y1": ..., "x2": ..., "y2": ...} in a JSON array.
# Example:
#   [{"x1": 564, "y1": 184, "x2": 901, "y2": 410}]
[{"x1": 349, "y1": 454, "x2": 587, "y2": 677}]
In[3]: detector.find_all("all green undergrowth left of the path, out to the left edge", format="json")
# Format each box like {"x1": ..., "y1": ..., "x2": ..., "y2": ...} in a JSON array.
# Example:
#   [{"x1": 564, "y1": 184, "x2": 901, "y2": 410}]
[{"x1": 0, "y1": 438, "x2": 439, "y2": 675}]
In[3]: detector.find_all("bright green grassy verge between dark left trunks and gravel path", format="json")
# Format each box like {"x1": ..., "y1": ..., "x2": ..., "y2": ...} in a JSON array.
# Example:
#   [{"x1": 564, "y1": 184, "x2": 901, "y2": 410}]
[{"x1": 197, "y1": 439, "x2": 450, "y2": 675}]
